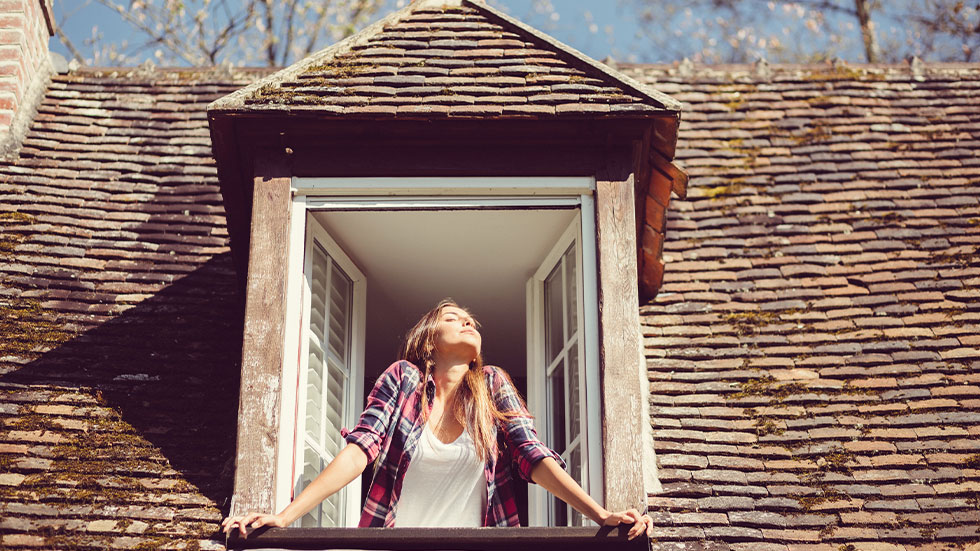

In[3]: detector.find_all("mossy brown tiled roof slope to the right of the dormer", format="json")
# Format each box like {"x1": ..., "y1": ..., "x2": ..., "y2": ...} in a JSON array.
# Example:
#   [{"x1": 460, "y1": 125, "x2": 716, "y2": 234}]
[{"x1": 624, "y1": 65, "x2": 980, "y2": 551}]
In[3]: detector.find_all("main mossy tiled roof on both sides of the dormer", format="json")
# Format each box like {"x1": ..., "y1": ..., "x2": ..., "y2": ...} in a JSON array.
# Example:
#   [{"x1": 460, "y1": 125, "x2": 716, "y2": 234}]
[{"x1": 0, "y1": 60, "x2": 980, "y2": 551}]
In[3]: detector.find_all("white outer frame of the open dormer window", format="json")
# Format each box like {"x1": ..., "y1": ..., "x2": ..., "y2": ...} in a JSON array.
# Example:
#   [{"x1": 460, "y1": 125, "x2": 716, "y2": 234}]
[{"x1": 275, "y1": 176, "x2": 603, "y2": 526}]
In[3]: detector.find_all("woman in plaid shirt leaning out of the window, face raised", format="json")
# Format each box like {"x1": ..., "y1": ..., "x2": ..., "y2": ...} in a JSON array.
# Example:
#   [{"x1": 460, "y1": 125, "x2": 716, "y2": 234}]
[{"x1": 222, "y1": 300, "x2": 653, "y2": 539}]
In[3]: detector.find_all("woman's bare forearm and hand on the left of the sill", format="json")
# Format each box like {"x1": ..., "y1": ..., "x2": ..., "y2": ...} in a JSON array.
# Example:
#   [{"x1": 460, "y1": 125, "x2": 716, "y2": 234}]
[{"x1": 221, "y1": 444, "x2": 368, "y2": 538}]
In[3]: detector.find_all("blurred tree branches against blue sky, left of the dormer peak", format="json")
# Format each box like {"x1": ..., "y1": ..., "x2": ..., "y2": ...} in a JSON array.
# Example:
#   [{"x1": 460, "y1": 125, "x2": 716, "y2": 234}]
[{"x1": 55, "y1": 0, "x2": 390, "y2": 66}]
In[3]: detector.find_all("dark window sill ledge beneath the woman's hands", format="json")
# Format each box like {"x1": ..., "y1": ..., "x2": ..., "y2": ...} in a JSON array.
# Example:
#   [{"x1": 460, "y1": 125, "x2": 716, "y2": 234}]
[{"x1": 227, "y1": 527, "x2": 650, "y2": 551}]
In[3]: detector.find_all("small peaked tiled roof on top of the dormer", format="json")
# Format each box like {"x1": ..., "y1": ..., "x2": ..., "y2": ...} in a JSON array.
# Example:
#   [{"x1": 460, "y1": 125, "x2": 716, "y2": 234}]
[{"x1": 211, "y1": 0, "x2": 677, "y2": 119}]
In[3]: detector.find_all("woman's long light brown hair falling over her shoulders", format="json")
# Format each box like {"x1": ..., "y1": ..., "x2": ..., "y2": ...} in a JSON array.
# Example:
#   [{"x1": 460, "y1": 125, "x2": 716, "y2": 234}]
[{"x1": 399, "y1": 298, "x2": 521, "y2": 460}]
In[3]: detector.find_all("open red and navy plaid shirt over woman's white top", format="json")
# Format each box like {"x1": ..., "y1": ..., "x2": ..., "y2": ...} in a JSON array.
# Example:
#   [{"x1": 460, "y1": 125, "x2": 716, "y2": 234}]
[{"x1": 344, "y1": 361, "x2": 565, "y2": 527}]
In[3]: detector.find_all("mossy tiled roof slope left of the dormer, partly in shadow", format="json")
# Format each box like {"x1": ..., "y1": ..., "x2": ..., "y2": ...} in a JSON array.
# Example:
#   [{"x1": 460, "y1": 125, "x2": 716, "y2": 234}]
[{"x1": 0, "y1": 70, "x2": 268, "y2": 549}]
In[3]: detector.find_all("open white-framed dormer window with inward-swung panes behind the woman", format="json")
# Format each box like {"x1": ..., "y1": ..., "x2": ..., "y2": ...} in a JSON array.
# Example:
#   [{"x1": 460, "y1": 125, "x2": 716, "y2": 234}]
[{"x1": 276, "y1": 178, "x2": 602, "y2": 527}]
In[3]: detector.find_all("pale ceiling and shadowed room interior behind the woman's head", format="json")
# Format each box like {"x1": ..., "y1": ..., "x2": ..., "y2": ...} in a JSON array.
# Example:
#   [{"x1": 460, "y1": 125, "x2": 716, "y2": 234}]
[{"x1": 315, "y1": 209, "x2": 577, "y2": 392}]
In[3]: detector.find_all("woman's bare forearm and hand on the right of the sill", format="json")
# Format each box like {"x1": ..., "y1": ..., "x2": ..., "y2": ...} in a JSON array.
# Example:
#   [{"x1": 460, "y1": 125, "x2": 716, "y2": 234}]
[{"x1": 531, "y1": 457, "x2": 653, "y2": 539}]
